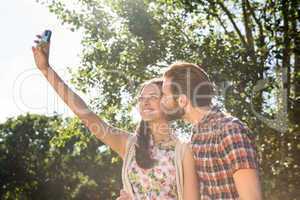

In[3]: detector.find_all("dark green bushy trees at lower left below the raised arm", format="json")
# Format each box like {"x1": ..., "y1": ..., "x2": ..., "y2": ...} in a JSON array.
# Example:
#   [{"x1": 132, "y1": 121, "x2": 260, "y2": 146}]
[{"x1": 0, "y1": 114, "x2": 121, "y2": 200}]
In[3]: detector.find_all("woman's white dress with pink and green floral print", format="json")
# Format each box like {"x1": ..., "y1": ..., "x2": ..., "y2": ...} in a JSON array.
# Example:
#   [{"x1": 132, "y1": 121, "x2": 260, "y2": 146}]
[{"x1": 128, "y1": 135, "x2": 177, "y2": 200}]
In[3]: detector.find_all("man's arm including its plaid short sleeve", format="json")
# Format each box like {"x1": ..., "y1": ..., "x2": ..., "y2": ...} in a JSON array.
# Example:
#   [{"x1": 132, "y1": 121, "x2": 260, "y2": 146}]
[{"x1": 222, "y1": 122, "x2": 262, "y2": 200}]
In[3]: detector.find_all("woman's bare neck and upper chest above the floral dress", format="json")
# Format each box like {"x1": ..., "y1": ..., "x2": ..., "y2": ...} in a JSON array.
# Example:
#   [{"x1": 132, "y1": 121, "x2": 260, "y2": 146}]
[{"x1": 149, "y1": 121, "x2": 171, "y2": 143}]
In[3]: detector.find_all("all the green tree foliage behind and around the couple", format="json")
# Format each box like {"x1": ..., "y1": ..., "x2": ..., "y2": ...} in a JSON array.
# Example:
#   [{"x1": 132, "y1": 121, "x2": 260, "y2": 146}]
[{"x1": 0, "y1": 0, "x2": 300, "y2": 200}]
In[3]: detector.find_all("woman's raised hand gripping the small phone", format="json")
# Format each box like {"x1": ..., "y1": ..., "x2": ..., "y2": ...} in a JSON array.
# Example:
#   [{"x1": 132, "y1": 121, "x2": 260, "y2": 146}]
[{"x1": 32, "y1": 35, "x2": 50, "y2": 70}]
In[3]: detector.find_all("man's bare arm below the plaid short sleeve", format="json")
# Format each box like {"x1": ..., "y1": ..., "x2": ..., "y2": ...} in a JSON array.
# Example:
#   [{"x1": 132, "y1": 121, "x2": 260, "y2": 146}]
[{"x1": 233, "y1": 169, "x2": 262, "y2": 200}]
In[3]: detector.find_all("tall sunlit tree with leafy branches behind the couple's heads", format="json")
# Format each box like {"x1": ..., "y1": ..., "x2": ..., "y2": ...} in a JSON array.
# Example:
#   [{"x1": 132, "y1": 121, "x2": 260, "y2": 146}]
[{"x1": 33, "y1": 0, "x2": 300, "y2": 199}]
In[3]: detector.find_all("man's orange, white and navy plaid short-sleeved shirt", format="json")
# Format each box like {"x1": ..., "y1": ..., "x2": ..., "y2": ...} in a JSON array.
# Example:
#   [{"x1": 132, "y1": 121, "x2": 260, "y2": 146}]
[{"x1": 192, "y1": 107, "x2": 258, "y2": 200}]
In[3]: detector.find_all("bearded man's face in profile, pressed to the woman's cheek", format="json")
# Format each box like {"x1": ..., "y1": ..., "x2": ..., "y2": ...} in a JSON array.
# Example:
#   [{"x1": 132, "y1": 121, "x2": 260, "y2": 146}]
[{"x1": 161, "y1": 77, "x2": 185, "y2": 120}]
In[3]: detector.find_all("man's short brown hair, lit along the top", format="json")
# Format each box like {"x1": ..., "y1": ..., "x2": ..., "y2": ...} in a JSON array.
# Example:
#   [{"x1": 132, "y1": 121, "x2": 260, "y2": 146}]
[{"x1": 164, "y1": 62, "x2": 214, "y2": 107}]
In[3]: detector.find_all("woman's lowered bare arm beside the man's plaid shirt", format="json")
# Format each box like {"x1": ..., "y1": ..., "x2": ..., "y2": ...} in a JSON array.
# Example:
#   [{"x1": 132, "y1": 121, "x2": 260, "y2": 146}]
[{"x1": 183, "y1": 146, "x2": 199, "y2": 200}]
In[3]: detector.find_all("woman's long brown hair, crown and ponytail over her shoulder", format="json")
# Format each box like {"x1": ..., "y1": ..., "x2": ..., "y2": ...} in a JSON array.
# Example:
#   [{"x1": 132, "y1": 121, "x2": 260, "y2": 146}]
[{"x1": 135, "y1": 78, "x2": 163, "y2": 169}]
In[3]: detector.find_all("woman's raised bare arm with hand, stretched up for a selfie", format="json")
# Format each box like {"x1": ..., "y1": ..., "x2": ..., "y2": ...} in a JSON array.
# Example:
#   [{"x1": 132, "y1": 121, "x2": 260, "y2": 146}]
[{"x1": 32, "y1": 36, "x2": 129, "y2": 158}]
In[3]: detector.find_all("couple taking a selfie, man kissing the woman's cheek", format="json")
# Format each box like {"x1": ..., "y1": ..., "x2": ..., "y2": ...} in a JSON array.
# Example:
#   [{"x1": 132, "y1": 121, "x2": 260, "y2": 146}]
[{"x1": 32, "y1": 36, "x2": 261, "y2": 200}]
